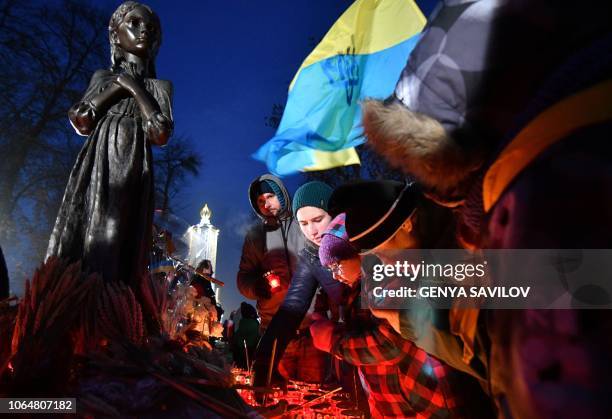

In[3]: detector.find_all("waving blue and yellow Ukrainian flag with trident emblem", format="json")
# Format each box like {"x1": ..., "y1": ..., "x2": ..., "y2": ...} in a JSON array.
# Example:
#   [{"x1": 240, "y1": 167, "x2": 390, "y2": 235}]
[{"x1": 253, "y1": 0, "x2": 426, "y2": 176}]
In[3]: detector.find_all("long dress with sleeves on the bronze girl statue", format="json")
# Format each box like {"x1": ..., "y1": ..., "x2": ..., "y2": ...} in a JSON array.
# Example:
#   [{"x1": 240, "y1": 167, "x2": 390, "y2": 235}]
[{"x1": 47, "y1": 70, "x2": 172, "y2": 284}]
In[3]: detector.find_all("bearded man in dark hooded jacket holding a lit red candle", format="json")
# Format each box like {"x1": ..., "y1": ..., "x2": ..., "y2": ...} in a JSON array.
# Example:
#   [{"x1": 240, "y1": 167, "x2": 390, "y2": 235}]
[{"x1": 237, "y1": 174, "x2": 304, "y2": 331}]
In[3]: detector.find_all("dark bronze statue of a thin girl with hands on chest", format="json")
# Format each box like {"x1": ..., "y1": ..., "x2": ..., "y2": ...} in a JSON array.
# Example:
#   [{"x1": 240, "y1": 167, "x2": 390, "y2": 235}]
[{"x1": 47, "y1": 1, "x2": 173, "y2": 284}]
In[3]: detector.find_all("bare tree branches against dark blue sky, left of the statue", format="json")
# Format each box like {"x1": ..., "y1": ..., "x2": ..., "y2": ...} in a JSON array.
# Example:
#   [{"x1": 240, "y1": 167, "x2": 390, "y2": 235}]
[{"x1": 0, "y1": 0, "x2": 112, "y2": 282}]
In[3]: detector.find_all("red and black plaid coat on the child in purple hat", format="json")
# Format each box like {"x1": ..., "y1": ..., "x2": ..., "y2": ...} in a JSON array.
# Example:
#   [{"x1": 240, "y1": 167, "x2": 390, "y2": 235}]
[{"x1": 331, "y1": 289, "x2": 463, "y2": 419}]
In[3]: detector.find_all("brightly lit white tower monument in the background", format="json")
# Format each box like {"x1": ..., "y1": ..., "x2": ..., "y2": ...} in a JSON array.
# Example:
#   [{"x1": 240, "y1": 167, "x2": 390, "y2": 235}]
[{"x1": 185, "y1": 204, "x2": 219, "y2": 301}]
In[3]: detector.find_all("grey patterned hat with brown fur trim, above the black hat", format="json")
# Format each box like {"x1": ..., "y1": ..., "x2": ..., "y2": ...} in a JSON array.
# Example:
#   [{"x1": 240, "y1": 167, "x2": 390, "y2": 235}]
[{"x1": 362, "y1": 0, "x2": 503, "y2": 205}]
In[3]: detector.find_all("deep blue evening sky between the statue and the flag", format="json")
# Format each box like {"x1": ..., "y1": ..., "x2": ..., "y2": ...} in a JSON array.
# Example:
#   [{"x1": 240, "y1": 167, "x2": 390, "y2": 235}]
[{"x1": 77, "y1": 0, "x2": 436, "y2": 312}]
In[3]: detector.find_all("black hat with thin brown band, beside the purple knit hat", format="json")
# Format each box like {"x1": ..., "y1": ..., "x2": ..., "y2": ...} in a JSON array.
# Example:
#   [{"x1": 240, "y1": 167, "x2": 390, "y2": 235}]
[{"x1": 329, "y1": 180, "x2": 421, "y2": 252}]
